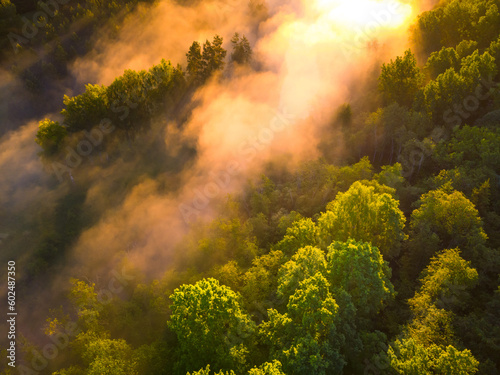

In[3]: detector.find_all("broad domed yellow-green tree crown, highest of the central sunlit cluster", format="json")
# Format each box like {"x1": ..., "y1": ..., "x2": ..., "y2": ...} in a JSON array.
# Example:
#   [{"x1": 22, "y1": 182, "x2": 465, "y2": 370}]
[{"x1": 318, "y1": 181, "x2": 406, "y2": 259}]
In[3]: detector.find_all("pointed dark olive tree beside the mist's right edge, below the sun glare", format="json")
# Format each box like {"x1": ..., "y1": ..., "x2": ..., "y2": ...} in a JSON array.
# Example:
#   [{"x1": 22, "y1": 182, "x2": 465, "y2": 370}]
[{"x1": 379, "y1": 50, "x2": 422, "y2": 107}]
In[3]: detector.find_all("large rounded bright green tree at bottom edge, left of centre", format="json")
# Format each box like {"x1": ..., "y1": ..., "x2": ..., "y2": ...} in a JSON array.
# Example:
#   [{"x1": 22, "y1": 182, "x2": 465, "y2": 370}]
[{"x1": 168, "y1": 279, "x2": 254, "y2": 371}]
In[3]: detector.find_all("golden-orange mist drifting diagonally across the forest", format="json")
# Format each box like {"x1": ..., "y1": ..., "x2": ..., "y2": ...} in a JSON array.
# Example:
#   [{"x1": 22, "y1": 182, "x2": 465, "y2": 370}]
[{"x1": 0, "y1": 0, "x2": 427, "y2": 360}]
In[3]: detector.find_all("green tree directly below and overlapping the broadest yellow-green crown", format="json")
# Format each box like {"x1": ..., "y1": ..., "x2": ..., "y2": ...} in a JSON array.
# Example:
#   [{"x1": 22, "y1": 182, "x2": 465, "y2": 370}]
[{"x1": 327, "y1": 240, "x2": 395, "y2": 320}]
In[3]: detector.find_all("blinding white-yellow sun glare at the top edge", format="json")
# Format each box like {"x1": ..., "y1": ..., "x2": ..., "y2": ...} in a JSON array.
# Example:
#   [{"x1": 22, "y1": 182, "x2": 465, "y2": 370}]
[{"x1": 316, "y1": 0, "x2": 412, "y2": 29}]
